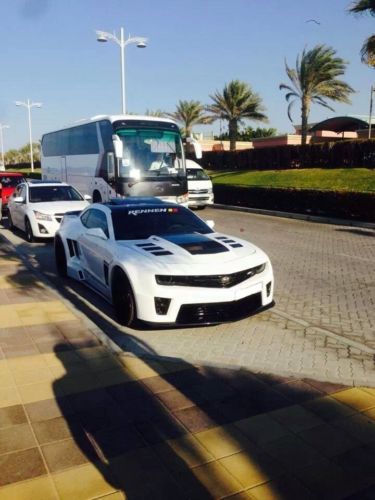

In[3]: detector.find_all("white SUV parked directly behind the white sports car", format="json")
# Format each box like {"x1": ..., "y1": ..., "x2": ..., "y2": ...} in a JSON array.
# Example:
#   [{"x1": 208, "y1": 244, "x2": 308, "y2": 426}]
[{"x1": 8, "y1": 180, "x2": 90, "y2": 242}]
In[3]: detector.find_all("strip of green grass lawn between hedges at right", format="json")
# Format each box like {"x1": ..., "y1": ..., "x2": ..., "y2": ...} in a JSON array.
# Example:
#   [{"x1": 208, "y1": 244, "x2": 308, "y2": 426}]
[{"x1": 212, "y1": 168, "x2": 375, "y2": 193}]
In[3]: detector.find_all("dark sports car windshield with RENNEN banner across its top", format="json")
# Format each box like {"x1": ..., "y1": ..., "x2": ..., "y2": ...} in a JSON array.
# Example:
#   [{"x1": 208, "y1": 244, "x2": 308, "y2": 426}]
[{"x1": 112, "y1": 206, "x2": 213, "y2": 240}]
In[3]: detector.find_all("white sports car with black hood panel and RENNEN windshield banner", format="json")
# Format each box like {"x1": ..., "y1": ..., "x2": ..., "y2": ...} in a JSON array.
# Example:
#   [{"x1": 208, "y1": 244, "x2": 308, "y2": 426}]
[{"x1": 55, "y1": 198, "x2": 273, "y2": 326}]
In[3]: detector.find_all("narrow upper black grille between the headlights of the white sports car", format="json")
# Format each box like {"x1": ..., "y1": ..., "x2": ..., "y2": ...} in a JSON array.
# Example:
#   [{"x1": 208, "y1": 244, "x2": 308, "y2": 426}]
[{"x1": 155, "y1": 264, "x2": 265, "y2": 288}]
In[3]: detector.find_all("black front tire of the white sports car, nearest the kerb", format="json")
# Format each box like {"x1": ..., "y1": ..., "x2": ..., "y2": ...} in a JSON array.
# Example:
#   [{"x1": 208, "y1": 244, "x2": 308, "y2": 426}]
[{"x1": 112, "y1": 272, "x2": 137, "y2": 327}]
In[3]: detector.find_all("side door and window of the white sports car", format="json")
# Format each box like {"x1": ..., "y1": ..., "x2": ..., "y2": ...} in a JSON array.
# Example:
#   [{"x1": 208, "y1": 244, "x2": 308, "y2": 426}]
[{"x1": 78, "y1": 208, "x2": 112, "y2": 295}]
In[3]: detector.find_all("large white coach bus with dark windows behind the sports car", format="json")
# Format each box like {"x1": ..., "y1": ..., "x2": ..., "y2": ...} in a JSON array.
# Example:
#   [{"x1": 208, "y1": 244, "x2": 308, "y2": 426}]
[{"x1": 41, "y1": 115, "x2": 201, "y2": 205}]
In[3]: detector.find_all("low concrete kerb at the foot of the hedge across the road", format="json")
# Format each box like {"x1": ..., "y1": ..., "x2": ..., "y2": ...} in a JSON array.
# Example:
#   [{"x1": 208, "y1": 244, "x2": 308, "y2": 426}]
[{"x1": 211, "y1": 203, "x2": 375, "y2": 229}]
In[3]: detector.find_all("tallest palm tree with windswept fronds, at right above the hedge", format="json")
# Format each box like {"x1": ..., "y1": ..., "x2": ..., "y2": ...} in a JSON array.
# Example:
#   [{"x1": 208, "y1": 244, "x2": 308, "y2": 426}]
[{"x1": 279, "y1": 45, "x2": 354, "y2": 144}]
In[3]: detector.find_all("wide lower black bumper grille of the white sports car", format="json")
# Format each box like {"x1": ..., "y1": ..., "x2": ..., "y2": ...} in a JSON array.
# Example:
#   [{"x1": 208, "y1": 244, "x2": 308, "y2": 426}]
[{"x1": 176, "y1": 292, "x2": 262, "y2": 325}]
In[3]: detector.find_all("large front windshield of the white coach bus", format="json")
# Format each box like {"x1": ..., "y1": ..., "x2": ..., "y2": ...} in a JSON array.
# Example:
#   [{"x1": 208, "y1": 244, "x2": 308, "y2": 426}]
[{"x1": 116, "y1": 128, "x2": 185, "y2": 180}]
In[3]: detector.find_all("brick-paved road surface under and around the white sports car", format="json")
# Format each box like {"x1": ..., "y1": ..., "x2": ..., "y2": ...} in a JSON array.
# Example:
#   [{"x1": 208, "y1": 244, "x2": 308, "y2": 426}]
[{"x1": 2, "y1": 209, "x2": 375, "y2": 386}]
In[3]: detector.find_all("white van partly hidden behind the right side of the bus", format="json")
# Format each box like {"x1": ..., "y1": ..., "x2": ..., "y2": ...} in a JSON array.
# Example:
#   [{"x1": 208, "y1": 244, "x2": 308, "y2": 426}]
[{"x1": 186, "y1": 160, "x2": 214, "y2": 208}]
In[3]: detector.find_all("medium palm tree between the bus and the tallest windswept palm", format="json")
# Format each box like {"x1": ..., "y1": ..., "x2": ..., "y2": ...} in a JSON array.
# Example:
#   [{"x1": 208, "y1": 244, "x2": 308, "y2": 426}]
[{"x1": 206, "y1": 80, "x2": 267, "y2": 151}]
